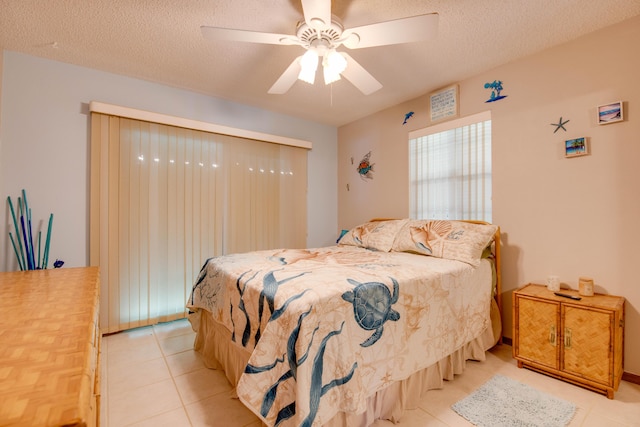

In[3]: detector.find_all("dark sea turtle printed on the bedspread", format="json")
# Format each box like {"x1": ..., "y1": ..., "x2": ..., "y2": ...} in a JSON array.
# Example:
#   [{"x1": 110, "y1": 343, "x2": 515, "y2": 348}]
[{"x1": 342, "y1": 277, "x2": 400, "y2": 347}]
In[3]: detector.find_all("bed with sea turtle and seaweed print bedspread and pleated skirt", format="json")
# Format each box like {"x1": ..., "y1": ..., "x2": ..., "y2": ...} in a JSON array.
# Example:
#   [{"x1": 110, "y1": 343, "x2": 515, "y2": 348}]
[{"x1": 187, "y1": 219, "x2": 501, "y2": 426}]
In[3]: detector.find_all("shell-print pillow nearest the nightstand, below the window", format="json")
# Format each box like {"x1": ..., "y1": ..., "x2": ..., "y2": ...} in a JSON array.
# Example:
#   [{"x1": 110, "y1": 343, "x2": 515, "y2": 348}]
[{"x1": 392, "y1": 220, "x2": 498, "y2": 267}]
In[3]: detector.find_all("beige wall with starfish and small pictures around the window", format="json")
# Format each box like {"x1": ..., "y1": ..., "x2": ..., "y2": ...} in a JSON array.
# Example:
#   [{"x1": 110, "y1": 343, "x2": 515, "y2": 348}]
[{"x1": 338, "y1": 17, "x2": 640, "y2": 375}]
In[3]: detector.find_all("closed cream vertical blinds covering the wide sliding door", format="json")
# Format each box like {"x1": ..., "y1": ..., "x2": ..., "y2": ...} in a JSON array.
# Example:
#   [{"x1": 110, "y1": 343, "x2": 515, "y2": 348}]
[{"x1": 90, "y1": 113, "x2": 307, "y2": 332}]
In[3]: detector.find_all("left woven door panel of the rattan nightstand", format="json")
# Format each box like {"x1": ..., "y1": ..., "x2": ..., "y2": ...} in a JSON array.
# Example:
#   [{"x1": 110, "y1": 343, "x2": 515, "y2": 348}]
[{"x1": 517, "y1": 297, "x2": 561, "y2": 369}]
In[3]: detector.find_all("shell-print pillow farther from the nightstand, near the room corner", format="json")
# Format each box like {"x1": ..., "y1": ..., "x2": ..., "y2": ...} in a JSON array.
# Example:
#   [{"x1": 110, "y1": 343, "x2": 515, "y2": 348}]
[{"x1": 338, "y1": 219, "x2": 408, "y2": 252}]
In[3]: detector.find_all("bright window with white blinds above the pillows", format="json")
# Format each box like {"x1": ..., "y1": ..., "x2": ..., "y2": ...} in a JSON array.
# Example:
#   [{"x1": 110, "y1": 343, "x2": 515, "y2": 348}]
[{"x1": 409, "y1": 111, "x2": 491, "y2": 222}]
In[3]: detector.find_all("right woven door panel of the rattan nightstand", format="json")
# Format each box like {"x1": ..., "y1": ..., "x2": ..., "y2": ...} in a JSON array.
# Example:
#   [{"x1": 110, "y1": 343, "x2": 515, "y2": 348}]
[{"x1": 562, "y1": 305, "x2": 613, "y2": 386}]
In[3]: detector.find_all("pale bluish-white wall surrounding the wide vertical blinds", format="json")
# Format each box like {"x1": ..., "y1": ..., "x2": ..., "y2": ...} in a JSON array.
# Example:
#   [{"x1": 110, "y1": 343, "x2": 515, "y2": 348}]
[{"x1": 0, "y1": 51, "x2": 338, "y2": 271}]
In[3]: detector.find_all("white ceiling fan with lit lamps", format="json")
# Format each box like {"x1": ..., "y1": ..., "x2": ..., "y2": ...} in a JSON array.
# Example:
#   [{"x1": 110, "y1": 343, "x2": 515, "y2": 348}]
[{"x1": 200, "y1": 0, "x2": 438, "y2": 95}]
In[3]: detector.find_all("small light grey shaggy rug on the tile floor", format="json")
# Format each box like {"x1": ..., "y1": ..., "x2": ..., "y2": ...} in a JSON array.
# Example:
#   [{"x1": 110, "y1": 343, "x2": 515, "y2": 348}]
[{"x1": 451, "y1": 375, "x2": 576, "y2": 427}]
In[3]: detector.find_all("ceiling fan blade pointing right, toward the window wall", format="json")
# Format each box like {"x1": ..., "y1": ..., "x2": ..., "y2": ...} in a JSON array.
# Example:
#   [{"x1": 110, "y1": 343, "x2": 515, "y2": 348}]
[{"x1": 342, "y1": 13, "x2": 438, "y2": 49}]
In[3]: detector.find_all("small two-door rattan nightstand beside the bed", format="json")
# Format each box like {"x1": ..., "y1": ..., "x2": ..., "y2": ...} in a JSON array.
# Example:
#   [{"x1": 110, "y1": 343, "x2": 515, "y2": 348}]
[{"x1": 513, "y1": 284, "x2": 624, "y2": 399}]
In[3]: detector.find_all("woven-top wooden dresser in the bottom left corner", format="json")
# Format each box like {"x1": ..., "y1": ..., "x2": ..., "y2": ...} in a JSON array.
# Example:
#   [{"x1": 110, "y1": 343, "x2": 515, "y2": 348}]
[{"x1": 0, "y1": 267, "x2": 101, "y2": 427}]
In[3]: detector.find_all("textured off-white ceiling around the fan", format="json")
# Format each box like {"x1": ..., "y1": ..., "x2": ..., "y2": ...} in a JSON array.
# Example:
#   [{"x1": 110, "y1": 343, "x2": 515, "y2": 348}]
[{"x1": 0, "y1": 0, "x2": 640, "y2": 126}]
